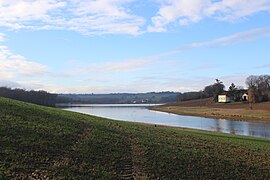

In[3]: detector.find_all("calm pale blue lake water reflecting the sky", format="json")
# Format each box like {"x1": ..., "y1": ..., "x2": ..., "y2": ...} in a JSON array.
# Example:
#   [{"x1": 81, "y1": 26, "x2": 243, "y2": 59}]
[{"x1": 62, "y1": 104, "x2": 270, "y2": 138}]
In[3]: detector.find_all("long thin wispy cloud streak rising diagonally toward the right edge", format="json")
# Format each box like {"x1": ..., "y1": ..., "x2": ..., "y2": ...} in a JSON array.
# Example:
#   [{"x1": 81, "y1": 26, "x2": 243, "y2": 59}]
[{"x1": 53, "y1": 27, "x2": 270, "y2": 78}]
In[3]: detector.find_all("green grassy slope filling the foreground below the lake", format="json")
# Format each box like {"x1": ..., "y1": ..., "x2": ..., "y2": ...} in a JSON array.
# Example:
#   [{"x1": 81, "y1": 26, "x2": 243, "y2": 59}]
[{"x1": 0, "y1": 98, "x2": 270, "y2": 179}]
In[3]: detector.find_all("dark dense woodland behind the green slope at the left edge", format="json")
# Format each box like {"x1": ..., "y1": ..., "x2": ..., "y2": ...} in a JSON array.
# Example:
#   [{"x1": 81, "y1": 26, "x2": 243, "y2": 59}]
[{"x1": 0, "y1": 87, "x2": 57, "y2": 107}]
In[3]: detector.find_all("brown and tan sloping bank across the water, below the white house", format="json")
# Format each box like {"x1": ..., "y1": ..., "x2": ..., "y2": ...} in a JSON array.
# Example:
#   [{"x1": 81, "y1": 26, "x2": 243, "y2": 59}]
[{"x1": 151, "y1": 99, "x2": 270, "y2": 123}]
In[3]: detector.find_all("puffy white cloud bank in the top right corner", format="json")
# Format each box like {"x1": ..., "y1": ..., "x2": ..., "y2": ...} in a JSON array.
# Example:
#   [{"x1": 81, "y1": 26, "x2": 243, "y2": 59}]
[{"x1": 148, "y1": 0, "x2": 270, "y2": 32}]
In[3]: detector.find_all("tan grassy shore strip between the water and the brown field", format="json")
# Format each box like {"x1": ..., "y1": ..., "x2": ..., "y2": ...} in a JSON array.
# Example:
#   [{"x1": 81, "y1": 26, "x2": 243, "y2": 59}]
[{"x1": 149, "y1": 105, "x2": 270, "y2": 124}]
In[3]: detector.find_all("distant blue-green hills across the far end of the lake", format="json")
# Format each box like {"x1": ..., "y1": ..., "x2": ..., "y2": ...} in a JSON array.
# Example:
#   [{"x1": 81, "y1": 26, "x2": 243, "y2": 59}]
[{"x1": 58, "y1": 92, "x2": 179, "y2": 104}]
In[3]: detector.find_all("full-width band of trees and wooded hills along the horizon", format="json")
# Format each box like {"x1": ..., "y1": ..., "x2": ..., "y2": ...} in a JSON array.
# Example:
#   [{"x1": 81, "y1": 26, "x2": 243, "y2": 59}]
[{"x1": 0, "y1": 75, "x2": 270, "y2": 106}]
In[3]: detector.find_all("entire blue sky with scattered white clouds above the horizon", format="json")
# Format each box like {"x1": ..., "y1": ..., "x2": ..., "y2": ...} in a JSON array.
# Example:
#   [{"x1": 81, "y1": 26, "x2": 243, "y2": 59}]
[{"x1": 0, "y1": 0, "x2": 270, "y2": 93}]
